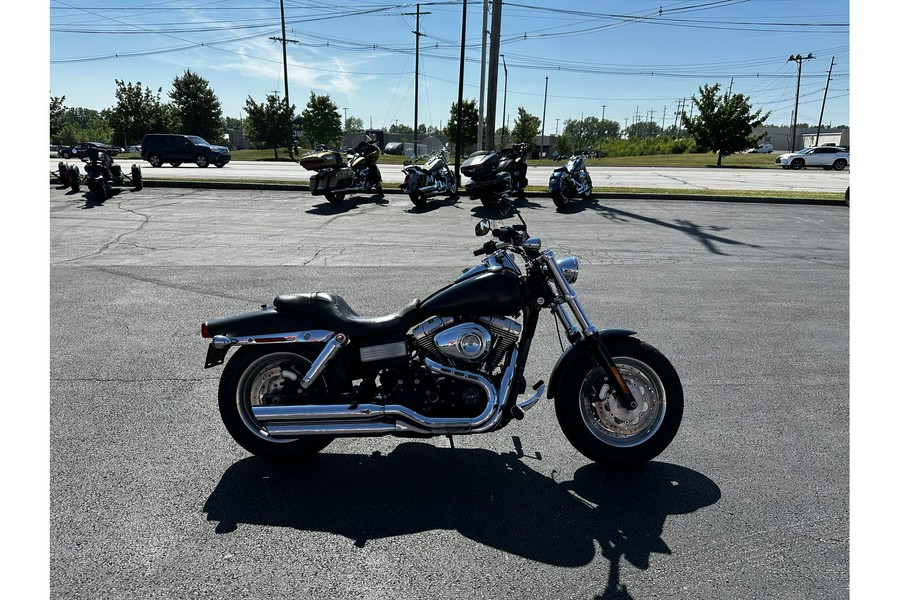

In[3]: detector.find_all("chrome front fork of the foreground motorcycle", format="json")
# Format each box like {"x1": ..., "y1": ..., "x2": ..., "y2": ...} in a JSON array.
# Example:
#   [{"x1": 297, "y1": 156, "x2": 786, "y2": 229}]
[{"x1": 540, "y1": 250, "x2": 637, "y2": 409}]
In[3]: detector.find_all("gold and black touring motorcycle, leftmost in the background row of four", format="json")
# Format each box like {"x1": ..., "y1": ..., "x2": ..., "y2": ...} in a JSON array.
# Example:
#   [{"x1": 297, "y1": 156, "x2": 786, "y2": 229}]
[{"x1": 300, "y1": 138, "x2": 382, "y2": 204}]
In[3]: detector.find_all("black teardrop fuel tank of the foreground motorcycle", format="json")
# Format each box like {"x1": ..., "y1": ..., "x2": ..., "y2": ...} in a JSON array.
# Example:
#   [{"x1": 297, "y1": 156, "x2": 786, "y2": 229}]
[{"x1": 419, "y1": 269, "x2": 524, "y2": 316}]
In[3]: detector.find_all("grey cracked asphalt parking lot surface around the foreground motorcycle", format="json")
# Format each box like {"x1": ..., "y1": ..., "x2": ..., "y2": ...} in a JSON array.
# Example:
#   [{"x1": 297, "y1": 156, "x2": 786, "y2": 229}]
[{"x1": 49, "y1": 185, "x2": 849, "y2": 600}]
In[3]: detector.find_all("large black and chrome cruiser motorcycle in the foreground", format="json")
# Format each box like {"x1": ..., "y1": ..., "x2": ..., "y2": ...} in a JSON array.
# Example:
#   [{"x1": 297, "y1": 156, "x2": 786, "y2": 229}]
[{"x1": 201, "y1": 206, "x2": 684, "y2": 468}]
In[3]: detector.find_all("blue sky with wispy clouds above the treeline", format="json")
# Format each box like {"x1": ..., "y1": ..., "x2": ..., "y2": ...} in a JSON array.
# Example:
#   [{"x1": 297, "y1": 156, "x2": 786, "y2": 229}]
[{"x1": 48, "y1": 0, "x2": 851, "y2": 134}]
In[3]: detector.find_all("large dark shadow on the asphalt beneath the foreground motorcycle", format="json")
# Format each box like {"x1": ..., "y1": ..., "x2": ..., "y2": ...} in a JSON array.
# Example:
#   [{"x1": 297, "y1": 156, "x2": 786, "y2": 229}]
[{"x1": 203, "y1": 442, "x2": 721, "y2": 568}]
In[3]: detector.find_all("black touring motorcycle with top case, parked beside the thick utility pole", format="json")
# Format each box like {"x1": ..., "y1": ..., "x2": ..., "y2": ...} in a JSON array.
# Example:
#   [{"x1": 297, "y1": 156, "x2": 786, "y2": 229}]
[{"x1": 460, "y1": 143, "x2": 529, "y2": 208}]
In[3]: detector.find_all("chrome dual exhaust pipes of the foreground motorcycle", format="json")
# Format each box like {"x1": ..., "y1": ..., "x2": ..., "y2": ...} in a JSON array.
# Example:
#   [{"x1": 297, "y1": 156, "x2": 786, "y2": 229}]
[{"x1": 251, "y1": 356, "x2": 518, "y2": 436}]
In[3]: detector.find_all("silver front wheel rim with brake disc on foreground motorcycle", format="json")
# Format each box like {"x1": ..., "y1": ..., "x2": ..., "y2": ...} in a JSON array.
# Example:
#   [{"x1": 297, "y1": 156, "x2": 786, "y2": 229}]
[{"x1": 578, "y1": 357, "x2": 666, "y2": 448}]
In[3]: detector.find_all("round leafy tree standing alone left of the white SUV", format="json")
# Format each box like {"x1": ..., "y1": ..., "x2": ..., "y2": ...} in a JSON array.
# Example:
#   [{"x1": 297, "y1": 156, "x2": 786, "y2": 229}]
[{"x1": 681, "y1": 83, "x2": 771, "y2": 166}]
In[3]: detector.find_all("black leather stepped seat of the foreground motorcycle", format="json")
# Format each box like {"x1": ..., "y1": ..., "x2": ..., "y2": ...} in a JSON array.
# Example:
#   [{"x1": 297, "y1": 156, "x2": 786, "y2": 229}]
[{"x1": 274, "y1": 292, "x2": 422, "y2": 339}]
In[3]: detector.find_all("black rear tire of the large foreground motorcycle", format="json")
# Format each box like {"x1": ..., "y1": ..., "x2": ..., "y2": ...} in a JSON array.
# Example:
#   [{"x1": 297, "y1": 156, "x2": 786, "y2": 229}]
[{"x1": 219, "y1": 346, "x2": 337, "y2": 461}]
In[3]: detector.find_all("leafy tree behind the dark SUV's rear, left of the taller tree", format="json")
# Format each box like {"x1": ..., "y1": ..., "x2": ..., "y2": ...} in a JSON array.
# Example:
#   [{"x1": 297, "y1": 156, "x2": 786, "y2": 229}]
[{"x1": 103, "y1": 79, "x2": 181, "y2": 146}]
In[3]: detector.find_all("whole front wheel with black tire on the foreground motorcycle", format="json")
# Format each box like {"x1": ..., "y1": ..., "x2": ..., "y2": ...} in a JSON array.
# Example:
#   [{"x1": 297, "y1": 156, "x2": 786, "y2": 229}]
[{"x1": 555, "y1": 337, "x2": 684, "y2": 469}]
